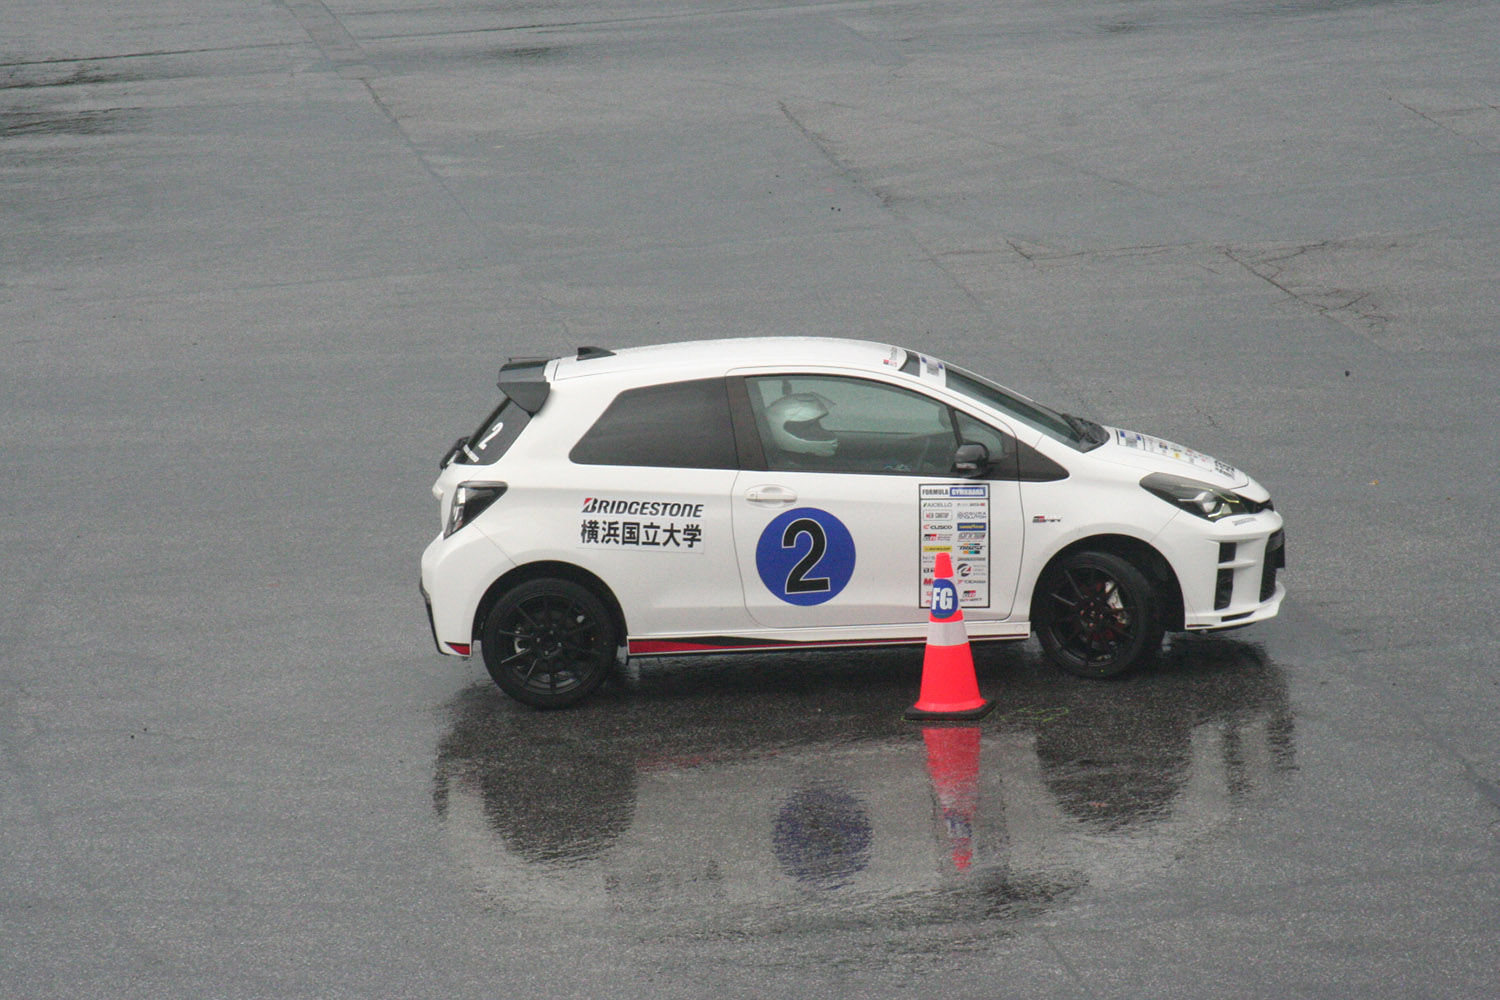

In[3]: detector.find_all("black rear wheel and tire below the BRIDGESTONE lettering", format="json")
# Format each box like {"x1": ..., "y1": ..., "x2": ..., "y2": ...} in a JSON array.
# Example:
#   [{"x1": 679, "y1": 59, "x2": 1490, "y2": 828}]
[{"x1": 480, "y1": 577, "x2": 620, "y2": 708}]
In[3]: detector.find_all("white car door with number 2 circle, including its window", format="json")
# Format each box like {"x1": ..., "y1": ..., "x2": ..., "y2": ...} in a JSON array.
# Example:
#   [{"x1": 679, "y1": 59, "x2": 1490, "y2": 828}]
[{"x1": 731, "y1": 373, "x2": 1020, "y2": 628}]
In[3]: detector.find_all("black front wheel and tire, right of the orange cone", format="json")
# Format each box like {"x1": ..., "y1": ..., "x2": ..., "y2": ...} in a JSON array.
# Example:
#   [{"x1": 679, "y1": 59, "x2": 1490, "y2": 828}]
[{"x1": 1037, "y1": 552, "x2": 1164, "y2": 678}]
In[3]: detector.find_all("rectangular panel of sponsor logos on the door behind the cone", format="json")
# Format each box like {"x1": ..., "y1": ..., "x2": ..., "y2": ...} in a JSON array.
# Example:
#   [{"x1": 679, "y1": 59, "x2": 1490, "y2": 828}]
[{"x1": 917, "y1": 483, "x2": 990, "y2": 607}]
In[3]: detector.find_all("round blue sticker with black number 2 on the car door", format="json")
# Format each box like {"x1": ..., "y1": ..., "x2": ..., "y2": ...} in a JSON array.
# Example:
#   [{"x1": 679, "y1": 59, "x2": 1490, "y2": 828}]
[{"x1": 755, "y1": 507, "x2": 854, "y2": 607}]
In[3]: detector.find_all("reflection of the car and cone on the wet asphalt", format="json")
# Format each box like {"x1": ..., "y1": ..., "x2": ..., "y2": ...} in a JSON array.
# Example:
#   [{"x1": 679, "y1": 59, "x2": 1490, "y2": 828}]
[{"x1": 435, "y1": 639, "x2": 1293, "y2": 933}]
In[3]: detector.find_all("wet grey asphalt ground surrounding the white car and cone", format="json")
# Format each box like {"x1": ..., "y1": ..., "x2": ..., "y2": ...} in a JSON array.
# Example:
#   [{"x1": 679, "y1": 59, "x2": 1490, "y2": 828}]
[{"x1": 0, "y1": 0, "x2": 1500, "y2": 1000}]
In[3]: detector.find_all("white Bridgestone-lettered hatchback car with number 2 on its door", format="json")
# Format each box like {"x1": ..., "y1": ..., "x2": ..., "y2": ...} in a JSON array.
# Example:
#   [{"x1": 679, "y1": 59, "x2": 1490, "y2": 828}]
[{"x1": 422, "y1": 337, "x2": 1284, "y2": 708}]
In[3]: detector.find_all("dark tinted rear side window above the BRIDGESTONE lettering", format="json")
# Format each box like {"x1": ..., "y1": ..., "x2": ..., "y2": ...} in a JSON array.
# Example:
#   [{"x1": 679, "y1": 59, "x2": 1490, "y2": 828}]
[{"x1": 569, "y1": 378, "x2": 740, "y2": 469}]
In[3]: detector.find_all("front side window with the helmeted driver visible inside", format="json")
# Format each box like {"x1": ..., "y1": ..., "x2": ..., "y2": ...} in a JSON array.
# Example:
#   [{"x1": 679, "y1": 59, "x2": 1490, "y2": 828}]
[{"x1": 746, "y1": 375, "x2": 957, "y2": 475}]
